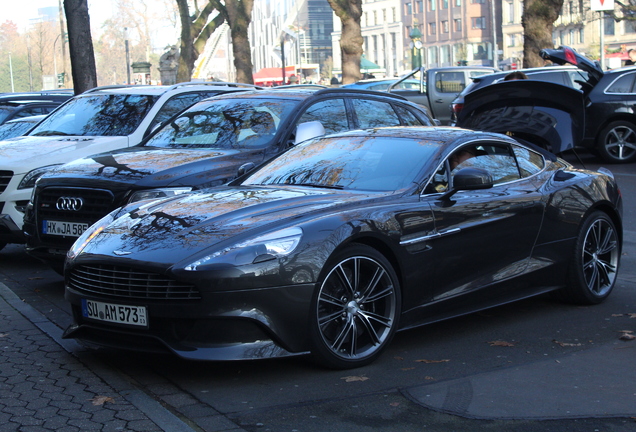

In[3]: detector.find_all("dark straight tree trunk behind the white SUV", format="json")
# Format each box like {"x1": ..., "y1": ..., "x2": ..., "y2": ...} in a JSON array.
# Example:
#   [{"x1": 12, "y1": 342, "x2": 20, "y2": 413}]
[{"x1": 64, "y1": 0, "x2": 97, "y2": 94}]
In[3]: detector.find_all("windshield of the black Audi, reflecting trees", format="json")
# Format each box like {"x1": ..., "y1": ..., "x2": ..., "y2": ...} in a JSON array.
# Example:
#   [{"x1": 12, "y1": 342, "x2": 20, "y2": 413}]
[{"x1": 144, "y1": 98, "x2": 300, "y2": 149}]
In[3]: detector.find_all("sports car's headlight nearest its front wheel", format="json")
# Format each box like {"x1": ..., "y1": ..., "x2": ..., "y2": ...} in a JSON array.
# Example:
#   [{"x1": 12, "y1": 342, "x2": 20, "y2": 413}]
[{"x1": 185, "y1": 227, "x2": 303, "y2": 271}]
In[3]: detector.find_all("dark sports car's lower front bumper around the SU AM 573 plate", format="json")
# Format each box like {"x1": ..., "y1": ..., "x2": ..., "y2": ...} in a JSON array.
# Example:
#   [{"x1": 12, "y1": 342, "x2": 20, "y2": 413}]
[{"x1": 64, "y1": 284, "x2": 314, "y2": 361}]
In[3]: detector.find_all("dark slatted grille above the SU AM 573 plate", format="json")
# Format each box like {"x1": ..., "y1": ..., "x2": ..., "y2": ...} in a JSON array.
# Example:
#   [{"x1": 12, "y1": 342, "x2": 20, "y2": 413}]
[{"x1": 68, "y1": 264, "x2": 201, "y2": 300}]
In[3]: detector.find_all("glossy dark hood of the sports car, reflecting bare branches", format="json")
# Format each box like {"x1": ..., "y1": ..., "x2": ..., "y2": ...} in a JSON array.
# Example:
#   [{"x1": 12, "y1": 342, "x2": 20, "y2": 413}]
[{"x1": 76, "y1": 187, "x2": 372, "y2": 265}]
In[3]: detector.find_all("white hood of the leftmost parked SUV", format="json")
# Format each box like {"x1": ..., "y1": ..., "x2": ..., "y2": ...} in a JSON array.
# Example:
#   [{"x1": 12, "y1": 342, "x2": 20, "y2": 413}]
[{"x1": 0, "y1": 136, "x2": 128, "y2": 174}]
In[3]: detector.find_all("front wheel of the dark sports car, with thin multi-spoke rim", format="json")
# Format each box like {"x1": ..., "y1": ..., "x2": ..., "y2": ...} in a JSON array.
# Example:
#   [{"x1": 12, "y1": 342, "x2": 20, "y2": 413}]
[{"x1": 310, "y1": 244, "x2": 401, "y2": 369}]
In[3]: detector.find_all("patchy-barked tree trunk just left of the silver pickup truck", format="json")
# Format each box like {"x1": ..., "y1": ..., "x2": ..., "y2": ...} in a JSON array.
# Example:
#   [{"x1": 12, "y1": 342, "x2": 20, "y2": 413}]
[{"x1": 327, "y1": 0, "x2": 362, "y2": 84}]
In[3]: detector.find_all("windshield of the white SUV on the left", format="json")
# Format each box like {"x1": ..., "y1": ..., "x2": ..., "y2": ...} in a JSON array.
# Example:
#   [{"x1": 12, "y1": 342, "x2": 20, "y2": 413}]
[{"x1": 29, "y1": 94, "x2": 158, "y2": 136}]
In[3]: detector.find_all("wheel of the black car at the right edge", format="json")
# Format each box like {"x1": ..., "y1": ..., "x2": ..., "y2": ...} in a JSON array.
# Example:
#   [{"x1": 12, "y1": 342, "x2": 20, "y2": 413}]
[{"x1": 596, "y1": 120, "x2": 636, "y2": 163}]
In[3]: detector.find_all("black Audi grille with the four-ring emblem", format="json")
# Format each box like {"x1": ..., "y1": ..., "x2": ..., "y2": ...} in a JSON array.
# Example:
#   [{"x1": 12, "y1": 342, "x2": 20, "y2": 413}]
[{"x1": 36, "y1": 188, "x2": 114, "y2": 224}]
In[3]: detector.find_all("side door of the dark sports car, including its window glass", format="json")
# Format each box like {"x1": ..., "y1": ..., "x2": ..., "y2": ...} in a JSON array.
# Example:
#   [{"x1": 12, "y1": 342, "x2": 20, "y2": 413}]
[{"x1": 423, "y1": 141, "x2": 544, "y2": 300}]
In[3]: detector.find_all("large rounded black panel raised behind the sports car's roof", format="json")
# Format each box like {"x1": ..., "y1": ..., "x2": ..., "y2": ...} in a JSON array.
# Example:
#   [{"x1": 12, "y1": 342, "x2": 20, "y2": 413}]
[{"x1": 457, "y1": 80, "x2": 585, "y2": 153}]
